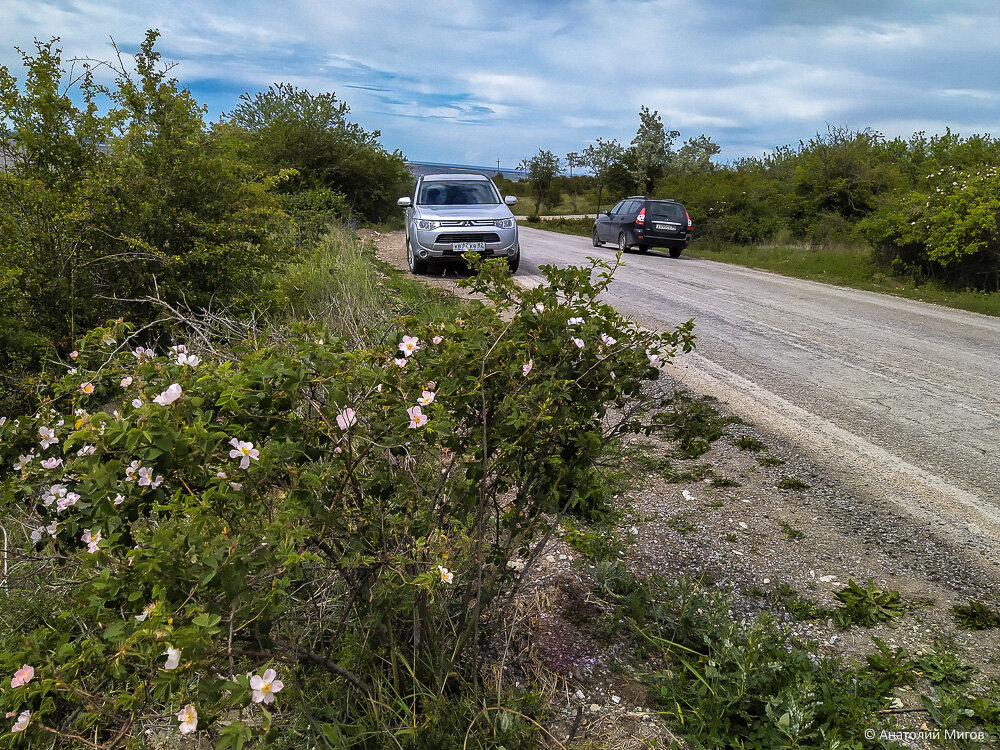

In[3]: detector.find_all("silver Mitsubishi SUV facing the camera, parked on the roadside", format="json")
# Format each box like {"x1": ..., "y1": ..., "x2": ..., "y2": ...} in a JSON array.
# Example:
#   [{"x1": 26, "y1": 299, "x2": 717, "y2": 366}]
[{"x1": 396, "y1": 174, "x2": 521, "y2": 273}]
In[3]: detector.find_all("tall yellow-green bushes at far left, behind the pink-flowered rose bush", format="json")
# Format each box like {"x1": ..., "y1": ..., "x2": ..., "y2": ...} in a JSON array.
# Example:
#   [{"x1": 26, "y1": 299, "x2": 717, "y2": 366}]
[{"x1": 0, "y1": 32, "x2": 290, "y2": 418}]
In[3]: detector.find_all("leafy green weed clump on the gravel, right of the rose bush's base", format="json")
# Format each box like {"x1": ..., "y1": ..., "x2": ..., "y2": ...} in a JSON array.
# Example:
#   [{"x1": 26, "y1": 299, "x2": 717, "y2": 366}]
[{"x1": 602, "y1": 577, "x2": 892, "y2": 748}]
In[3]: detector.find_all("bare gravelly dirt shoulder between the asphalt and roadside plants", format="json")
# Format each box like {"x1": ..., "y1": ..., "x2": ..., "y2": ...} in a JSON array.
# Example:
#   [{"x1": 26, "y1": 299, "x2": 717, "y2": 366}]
[{"x1": 356, "y1": 232, "x2": 1000, "y2": 748}]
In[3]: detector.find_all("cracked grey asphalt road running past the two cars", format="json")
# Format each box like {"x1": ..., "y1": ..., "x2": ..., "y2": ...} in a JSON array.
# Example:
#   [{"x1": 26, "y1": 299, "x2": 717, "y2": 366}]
[{"x1": 517, "y1": 228, "x2": 1000, "y2": 555}]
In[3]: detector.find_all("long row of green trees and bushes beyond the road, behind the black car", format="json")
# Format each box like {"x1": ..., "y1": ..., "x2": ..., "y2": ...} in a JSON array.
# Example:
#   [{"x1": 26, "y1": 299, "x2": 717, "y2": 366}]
[{"x1": 500, "y1": 118, "x2": 1000, "y2": 291}]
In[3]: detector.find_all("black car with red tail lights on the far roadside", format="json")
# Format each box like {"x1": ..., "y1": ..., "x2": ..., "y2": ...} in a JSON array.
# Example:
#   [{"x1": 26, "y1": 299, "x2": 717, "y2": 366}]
[{"x1": 593, "y1": 195, "x2": 691, "y2": 258}]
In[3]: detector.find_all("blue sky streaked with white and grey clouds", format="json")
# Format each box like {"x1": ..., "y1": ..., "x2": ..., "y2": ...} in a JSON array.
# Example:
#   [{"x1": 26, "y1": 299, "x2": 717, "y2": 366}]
[{"x1": 0, "y1": 0, "x2": 1000, "y2": 167}]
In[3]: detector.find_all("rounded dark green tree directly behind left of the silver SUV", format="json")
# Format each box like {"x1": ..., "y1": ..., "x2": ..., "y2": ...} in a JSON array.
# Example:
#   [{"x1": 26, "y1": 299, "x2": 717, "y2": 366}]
[{"x1": 220, "y1": 83, "x2": 412, "y2": 220}]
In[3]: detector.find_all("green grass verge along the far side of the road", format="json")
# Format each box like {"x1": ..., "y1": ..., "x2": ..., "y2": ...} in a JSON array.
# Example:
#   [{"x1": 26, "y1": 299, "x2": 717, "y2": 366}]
[{"x1": 521, "y1": 219, "x2": 1000, "y2": 317}]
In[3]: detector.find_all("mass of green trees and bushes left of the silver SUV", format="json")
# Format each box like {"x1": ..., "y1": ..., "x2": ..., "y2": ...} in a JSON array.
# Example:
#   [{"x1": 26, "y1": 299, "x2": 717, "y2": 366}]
[{"x1": 0, "y1": 31, "x2": 411, "y2": 415}]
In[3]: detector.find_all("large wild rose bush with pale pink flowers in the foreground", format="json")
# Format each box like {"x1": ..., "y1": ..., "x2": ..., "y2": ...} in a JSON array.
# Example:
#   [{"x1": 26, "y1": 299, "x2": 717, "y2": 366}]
[{"x1": 0, "y1": 264, "x2": 692, "y2": 748}]
